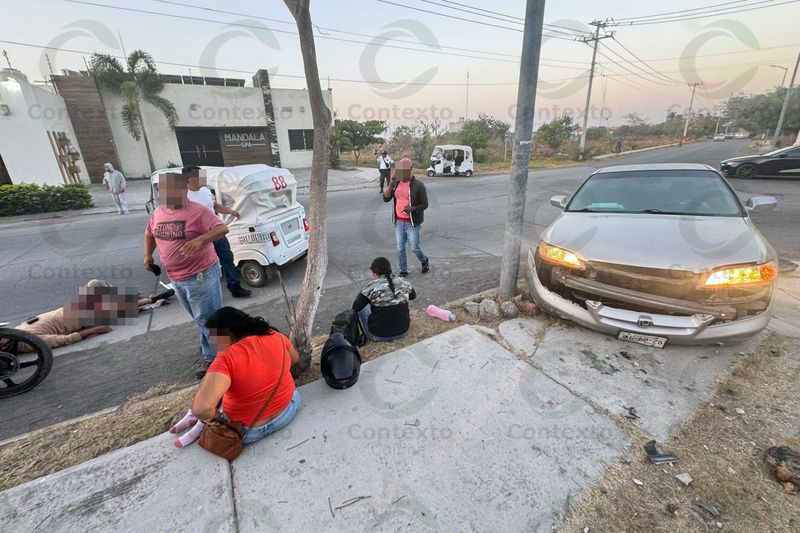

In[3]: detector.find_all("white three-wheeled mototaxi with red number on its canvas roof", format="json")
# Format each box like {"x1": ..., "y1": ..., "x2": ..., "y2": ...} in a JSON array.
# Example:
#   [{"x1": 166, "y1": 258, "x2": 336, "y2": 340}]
[{"x1": 147, "y1": 165, "x2": 310, "y2": 287}]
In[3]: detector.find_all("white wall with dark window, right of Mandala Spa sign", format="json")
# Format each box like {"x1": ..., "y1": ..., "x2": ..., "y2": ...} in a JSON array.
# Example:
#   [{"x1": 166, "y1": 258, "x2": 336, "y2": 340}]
[{"x1": 272, "y1": 88, "x2": 333, "y2": 170}]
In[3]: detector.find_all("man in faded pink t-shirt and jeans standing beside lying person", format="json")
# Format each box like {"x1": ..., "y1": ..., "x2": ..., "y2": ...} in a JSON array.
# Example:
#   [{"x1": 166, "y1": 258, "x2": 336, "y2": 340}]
[{"x1": 144, "y1": 173, "x2": 228, "y2": 378}]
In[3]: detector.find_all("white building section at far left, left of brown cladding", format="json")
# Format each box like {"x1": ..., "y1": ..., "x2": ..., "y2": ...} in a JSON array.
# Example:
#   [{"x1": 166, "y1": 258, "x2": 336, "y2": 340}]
[{"x1": 0, "y1": 69, "x2": 89, "y2": 185}]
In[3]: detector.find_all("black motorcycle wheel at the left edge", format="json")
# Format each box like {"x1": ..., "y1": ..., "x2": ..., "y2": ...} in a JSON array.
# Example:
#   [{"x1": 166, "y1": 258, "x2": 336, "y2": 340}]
[{"x1": 0, "y1": 328, "x2": 53, "y2": 398}]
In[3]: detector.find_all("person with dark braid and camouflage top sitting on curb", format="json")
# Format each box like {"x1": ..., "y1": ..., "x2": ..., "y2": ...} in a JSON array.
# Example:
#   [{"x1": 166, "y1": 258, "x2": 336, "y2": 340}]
[{"x1": 353, "y1": 257, "x2": 417, "y2": 342}]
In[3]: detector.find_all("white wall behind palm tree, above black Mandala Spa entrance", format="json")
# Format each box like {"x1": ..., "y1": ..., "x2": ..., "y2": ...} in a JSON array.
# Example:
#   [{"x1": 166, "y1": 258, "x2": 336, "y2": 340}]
[{"x1": 103, "y1": 83, "x2": 266, "y2": 177}]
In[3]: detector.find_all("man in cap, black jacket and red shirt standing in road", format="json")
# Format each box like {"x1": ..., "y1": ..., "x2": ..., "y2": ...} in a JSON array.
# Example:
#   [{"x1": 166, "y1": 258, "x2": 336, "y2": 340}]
[{"x1": 383, "y1": 157, "x2": 430, "y2": 277}]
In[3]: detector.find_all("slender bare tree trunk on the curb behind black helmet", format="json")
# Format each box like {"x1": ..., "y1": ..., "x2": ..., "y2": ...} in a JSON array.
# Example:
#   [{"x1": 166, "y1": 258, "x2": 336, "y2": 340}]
[{"x1": 284, "y1": 0, "x2": 331, "y2": 374}]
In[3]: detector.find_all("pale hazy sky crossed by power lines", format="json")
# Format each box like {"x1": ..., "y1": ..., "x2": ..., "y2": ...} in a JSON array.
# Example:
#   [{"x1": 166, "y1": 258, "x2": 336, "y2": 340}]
[{"x1": 0, "y1": 0, "x2": 800, "y2": 127}]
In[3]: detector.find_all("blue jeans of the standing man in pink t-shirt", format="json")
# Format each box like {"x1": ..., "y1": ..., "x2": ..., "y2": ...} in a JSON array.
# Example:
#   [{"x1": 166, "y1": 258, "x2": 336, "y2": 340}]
[{"x1": 172, "y1": 261, "x2": 222, "y2": 363}]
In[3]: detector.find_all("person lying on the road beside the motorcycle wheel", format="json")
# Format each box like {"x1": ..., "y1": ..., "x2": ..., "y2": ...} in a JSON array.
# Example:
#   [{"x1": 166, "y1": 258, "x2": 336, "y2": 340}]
[{"x1": 17, "y1": 279, "x2": 175, "y2": 351}]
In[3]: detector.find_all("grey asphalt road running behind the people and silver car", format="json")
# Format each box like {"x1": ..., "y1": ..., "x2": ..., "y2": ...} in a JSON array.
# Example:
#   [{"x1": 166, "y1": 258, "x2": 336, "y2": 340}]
[{"x1": 0, "y1": 141, "x2": 800, "y2": 440}]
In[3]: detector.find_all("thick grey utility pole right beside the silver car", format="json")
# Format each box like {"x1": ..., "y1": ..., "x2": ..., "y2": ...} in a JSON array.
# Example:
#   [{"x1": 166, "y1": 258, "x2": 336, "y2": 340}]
[{"x1": 500, "y1": 0, "x2": 545, "y2": 301}]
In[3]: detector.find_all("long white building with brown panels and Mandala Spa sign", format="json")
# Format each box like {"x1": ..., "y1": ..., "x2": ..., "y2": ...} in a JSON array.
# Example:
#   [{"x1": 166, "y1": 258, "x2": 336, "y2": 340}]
[{"x1": 0, "y1": 70, "x2": 333, "y2": 184}]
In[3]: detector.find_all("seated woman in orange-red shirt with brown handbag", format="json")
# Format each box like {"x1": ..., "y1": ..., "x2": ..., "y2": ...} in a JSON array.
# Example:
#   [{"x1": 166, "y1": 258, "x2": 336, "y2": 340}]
[{"x1": 170, "y1": 307, "x2": 300, "y2": 448}]
